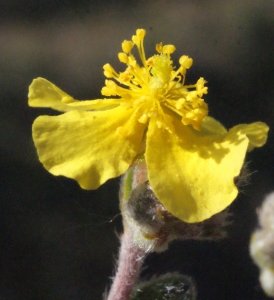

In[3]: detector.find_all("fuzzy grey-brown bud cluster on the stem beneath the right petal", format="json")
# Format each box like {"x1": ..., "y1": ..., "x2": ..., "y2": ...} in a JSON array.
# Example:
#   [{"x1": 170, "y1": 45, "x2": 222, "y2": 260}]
[{"x1": 121, "y1": 165, "x2": 228, "y2": 252}]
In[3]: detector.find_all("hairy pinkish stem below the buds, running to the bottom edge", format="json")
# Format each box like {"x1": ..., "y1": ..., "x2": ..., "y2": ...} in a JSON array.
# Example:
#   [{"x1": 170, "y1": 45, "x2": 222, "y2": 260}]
[{"x1": 107, "y1": 230, "x2": 146, "y2": 300}]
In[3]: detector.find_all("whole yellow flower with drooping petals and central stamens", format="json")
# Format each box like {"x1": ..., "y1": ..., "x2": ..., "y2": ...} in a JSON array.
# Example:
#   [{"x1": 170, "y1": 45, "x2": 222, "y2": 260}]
[{"x1": 29, "y1": 29, "x2": 268, "y2": 222}]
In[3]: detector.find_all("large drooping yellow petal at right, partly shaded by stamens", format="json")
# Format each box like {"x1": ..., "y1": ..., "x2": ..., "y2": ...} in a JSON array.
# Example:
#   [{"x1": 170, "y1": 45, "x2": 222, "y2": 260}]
[{"x1": 145, "y1": 119, "x2": 248, "y2": 223}]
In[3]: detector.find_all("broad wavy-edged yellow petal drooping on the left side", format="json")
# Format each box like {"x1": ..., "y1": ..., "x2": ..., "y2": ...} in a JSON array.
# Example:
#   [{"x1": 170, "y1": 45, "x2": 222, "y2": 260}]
[{"x1": 33, "y1": 107, "x2": 145, "y2": 189}]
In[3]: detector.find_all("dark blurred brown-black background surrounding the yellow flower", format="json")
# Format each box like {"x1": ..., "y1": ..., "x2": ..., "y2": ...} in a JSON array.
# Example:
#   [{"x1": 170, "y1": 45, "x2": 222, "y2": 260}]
[{"x1": 0, "y1": 0, "x2": 274, "y2": 300}]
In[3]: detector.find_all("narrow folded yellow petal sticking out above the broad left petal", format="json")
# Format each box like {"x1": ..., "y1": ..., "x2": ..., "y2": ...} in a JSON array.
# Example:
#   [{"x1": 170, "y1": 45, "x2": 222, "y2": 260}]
[{"x1": 28, "y1": 78, "x2": 119, "y2": 111}]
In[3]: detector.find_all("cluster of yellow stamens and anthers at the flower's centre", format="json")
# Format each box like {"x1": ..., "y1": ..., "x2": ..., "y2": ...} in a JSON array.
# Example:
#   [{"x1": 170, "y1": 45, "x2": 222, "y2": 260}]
[{"x1": 102, "y1": 29, "x2": 208, "y2": 130}]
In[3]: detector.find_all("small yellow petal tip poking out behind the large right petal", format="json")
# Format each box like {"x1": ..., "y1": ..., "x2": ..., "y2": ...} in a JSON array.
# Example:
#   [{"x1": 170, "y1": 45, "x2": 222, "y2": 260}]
[{"x1": 232, "y1": 122, "x2": 269, "y2": 151}]
